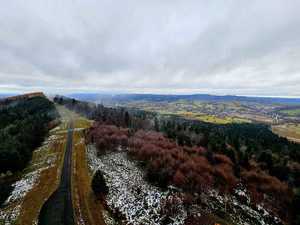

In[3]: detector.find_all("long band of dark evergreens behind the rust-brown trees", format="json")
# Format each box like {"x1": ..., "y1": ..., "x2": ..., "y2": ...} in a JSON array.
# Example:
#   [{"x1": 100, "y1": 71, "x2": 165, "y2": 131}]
[{"x1": 55, "y1": 97, "x2": 300, "y2": 187}]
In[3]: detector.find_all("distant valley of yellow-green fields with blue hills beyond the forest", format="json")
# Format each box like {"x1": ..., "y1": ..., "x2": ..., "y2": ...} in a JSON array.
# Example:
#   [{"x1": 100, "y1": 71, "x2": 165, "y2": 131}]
[{"x1": 67, "y1": 94, "x2": 300, "y2": 125}]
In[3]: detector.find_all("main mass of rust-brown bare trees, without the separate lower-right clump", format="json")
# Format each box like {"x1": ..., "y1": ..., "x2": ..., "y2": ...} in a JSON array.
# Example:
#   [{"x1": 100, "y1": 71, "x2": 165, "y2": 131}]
[{"x1": 88, "y1": 123, "x2": 236, "y2": 192}]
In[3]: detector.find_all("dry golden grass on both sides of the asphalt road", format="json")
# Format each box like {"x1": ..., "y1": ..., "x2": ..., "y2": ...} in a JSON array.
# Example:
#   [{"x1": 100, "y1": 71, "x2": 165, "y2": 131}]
[{"x1": 3, "y1": 106, "x2": 105, "y2": 225}]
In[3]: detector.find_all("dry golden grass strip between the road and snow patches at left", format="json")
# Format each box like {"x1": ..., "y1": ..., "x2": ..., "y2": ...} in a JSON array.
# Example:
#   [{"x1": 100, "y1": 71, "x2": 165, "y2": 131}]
[{"x1": 18, "y1": 105, "x2": 68, "y2": 225}]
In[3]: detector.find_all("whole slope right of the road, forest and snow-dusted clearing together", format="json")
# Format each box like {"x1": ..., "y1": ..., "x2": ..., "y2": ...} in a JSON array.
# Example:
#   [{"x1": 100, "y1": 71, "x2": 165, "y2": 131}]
[{"x1": 55, "y1": 97, "x2": 300, "y2": 224}]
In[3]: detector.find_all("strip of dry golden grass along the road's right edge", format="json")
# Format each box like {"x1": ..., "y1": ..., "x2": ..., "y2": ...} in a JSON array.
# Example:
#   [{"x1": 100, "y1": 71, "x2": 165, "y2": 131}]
[{"x1": 72, "y1": 125, "x2": 105, "y2": 225}]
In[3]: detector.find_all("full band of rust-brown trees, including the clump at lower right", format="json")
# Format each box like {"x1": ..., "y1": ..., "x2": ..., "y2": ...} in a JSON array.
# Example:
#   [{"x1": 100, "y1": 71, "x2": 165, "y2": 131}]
[{"x1": 87, "y1": 122, "x2": 292, "y2": 219}]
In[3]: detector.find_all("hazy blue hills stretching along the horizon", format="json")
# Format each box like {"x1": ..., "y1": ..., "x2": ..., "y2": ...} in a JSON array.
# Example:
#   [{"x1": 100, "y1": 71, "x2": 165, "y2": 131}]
[{"x1": 69, "y1": 93, "x2": 300, "y2": 105}]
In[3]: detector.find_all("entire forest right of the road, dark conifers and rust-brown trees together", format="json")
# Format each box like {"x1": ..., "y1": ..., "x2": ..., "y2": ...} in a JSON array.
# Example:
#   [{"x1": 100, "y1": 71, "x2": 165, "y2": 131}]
[{"x1": 55, "y1": 97, "x2": 300, "y2": 224}]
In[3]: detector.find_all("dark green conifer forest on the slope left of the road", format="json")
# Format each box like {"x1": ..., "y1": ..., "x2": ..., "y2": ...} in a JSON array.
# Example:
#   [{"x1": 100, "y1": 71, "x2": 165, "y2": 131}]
[{"x1": 0, "y1": 97, "x2": 58, "y2": 173}]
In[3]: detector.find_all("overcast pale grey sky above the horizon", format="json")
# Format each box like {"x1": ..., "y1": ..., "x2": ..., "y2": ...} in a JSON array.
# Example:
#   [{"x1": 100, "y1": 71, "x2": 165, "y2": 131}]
[{"x1": 0, "y1": 0, "x2": 300, "y2": 97}]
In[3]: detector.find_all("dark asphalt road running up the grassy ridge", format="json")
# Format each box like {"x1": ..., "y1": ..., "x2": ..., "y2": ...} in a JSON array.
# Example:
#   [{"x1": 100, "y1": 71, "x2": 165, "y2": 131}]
[{"x1": 38, "y1": 121, "x2": 75, "y2": 225}]
